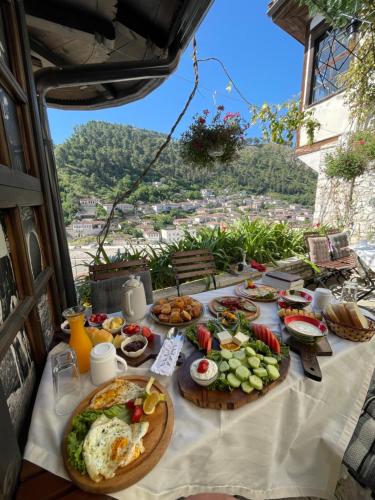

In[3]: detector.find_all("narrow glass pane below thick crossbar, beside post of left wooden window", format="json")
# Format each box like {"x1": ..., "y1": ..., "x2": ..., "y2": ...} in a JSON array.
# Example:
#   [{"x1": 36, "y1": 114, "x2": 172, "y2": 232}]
[{"x1": 20, "y1": 207, "x2": 45, "y2": 279}]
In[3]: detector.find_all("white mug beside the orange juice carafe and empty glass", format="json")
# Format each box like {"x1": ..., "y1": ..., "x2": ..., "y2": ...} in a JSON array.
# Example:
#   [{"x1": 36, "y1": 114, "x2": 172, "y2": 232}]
[{"x1": 90, "y1": 342, "x2": 128, "y2": 385}]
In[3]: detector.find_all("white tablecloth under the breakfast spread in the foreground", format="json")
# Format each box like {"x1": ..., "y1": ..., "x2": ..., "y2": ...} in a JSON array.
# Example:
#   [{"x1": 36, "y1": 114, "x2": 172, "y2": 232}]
[{"x1": 24, "y1": 287, "x2": 375, "y2": 500}]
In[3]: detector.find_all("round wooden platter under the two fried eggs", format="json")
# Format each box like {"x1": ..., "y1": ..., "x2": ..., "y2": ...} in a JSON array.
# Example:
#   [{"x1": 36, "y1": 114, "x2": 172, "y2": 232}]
[{"x1": 62, "y1": 376, "x2": 174, "y2": 494}]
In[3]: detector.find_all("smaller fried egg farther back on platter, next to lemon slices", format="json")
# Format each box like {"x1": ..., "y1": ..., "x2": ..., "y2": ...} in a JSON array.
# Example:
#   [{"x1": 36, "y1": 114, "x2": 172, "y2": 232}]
[{"x1": 90, "y1": 378, "x2": 144, "y2": 410}]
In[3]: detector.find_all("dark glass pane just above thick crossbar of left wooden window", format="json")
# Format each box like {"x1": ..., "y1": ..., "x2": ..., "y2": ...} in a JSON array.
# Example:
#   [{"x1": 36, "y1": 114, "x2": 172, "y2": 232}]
[{"x1": 0, "y1": 87, "x2": 26, "y2": 172}]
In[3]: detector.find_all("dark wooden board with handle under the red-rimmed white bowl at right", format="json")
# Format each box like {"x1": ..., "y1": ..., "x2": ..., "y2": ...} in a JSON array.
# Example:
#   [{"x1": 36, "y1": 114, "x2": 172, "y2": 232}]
[{"x1": 283, "y1": 327, "x2": 332, "y2": 382}]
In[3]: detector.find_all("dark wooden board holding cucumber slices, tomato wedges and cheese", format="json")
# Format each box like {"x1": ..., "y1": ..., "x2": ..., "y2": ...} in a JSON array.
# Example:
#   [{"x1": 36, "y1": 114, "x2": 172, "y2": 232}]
[{"x1": 177, "y1": 351, "x2": 290, "y2": 410}]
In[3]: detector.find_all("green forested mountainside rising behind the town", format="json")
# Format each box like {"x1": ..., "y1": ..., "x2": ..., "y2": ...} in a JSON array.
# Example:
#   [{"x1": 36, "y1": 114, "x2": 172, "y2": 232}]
[{"x1": 55, "y1": 121, "x2": 317, "y2": 222}]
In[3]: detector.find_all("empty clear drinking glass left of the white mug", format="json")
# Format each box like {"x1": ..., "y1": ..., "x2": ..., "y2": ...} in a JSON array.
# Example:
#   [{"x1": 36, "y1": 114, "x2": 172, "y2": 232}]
[{"x1": 51, "y1": 349, "x2": 82, "y2": 415}]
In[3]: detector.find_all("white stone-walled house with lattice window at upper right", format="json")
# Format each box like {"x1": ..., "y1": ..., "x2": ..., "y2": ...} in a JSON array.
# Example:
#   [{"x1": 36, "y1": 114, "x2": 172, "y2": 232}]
[{"x1": 268, "y1": 0, "x2": 375, "y2": 239}]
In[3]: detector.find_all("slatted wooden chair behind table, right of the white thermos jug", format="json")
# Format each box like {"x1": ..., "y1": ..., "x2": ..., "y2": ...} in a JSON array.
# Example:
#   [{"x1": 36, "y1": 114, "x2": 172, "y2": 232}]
[{"x1": 172, "y1": 249, "x2": 216, "y2": 295}]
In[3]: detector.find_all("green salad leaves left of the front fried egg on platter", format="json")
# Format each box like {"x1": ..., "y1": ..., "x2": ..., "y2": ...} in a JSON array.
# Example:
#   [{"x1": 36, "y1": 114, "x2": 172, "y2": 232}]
[{"x1": 67, "y1": 405, "x2": 131, "y2": 474}]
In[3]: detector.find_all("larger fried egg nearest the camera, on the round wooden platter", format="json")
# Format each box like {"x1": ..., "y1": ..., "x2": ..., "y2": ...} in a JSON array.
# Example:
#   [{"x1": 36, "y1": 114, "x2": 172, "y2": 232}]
[{"x1": 83, "y1": 415, "x2": 149, "y2": 482}]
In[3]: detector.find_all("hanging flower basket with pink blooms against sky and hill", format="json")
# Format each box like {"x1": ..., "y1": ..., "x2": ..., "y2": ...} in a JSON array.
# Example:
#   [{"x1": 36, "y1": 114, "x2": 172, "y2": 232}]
[{"x1": 181, "y1": 106, "x2": 249, "y2": 167}]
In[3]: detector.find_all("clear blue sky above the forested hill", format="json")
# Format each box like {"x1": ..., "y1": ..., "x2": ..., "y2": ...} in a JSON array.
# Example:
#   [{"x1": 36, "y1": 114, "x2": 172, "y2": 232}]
[{"x1": 49, "y1": 0, "x2": 303, "y2": 144}]
